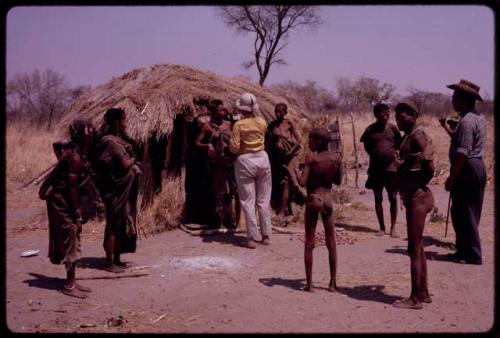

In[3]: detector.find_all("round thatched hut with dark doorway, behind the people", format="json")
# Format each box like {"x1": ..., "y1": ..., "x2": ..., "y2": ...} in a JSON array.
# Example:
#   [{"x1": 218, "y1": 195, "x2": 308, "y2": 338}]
[{"x1": 58, "y1": 65, "x2": 304, "y2": 223}]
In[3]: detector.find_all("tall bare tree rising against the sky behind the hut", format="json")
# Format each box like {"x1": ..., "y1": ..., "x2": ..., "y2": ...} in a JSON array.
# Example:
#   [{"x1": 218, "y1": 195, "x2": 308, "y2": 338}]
[{"x1": 217, "y1": 6, "x2": 320, "y2": 86}]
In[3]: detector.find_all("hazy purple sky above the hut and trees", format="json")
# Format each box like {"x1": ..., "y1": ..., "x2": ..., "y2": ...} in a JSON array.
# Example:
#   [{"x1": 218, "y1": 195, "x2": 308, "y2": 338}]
[{"x1": 6, "y1": 5, "x2": 495, "y2": 97}]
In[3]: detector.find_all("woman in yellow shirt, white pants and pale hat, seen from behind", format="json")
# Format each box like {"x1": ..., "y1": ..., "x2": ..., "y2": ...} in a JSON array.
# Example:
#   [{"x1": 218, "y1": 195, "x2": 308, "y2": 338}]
[{"x1": 229, "y1": 93, "x2": 271, "y2": 249}]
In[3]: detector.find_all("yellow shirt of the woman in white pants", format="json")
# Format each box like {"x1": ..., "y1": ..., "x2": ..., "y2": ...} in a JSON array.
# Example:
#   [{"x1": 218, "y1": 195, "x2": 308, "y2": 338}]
[{"x1": 229, "y1": 116, "x2": 267, "y2": 155}]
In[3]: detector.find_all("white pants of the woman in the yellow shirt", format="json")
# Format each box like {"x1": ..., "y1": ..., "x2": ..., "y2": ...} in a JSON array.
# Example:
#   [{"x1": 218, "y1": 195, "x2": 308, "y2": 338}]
[{"x1": 234, "y1": 150, "x2": 272, "y2": 240}]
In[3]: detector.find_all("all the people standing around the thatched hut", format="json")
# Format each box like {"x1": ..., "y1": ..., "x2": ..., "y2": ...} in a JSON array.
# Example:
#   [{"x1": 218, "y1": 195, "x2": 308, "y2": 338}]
[{"x1": 40, "y1": 80, "x2": 486, "y2": 309}]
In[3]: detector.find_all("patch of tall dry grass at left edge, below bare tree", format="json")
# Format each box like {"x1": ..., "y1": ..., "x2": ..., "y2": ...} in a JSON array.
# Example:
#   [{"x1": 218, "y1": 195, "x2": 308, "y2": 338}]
[{"x1": 5, "y1": 121, "x2": 56, "y2": 183}]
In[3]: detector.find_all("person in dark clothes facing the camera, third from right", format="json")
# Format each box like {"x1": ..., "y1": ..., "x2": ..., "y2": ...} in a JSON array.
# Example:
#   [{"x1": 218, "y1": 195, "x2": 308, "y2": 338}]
[{"x1": 360, "y1": 103, "x2": 402, "y2": 238}]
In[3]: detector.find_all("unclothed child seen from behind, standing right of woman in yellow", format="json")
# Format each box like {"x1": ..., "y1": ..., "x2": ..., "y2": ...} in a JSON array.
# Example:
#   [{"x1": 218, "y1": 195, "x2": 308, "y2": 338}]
[{"x1": 295, "y1": 128, "x2": 342, "y2": 292}]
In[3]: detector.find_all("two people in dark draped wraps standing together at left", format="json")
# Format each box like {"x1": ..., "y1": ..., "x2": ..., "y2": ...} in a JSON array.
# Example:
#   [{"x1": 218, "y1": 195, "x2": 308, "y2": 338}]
[{"x1": 39, "y1": 108, "x2": 141, "y2": 298}]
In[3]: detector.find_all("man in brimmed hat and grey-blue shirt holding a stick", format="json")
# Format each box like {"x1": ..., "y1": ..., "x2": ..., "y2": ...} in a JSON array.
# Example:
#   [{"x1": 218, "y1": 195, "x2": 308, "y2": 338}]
[{"x1": 445, "y1": 80, "x2": 486, "y2": 265}]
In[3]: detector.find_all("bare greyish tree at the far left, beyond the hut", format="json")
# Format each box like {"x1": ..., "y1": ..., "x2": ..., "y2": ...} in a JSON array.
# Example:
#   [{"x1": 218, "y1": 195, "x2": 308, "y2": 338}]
[{"x1": 6, "y1": 69, "x2": 75, "y2": 130}]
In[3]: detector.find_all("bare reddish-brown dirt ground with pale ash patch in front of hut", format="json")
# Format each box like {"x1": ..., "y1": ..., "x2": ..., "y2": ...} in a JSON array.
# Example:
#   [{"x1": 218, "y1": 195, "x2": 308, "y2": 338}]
[{"x1": 5, "y1": 178, "x2": 494, "y2": 333}]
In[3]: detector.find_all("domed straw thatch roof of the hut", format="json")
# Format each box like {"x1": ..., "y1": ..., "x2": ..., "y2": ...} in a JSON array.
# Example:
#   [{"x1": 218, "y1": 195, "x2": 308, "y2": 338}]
[{"x1": 59, "y1": 64, "x2": 305, "y2": 142}]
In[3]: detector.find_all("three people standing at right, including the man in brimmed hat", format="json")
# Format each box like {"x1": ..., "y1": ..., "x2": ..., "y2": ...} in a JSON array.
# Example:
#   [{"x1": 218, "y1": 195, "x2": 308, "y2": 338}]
[{"x1": 360, "y1": 80, "x2": 486, "y2": 309}]
